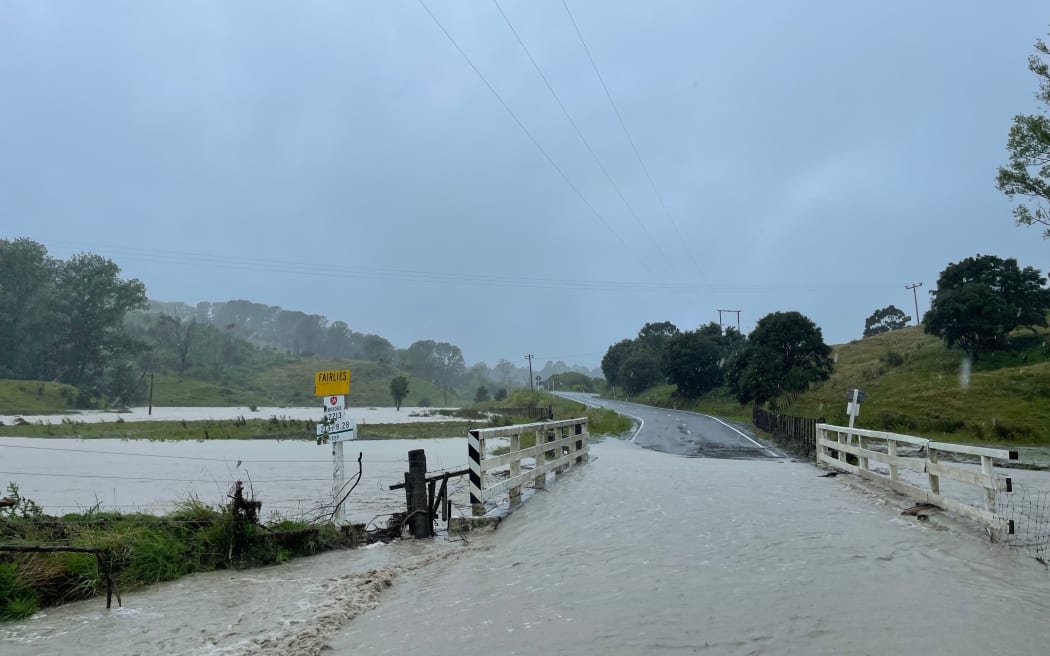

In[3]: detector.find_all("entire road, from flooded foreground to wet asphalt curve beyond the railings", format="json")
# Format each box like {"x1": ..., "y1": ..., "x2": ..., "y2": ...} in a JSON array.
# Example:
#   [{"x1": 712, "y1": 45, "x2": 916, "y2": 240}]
[{"x1": 331, "y1": 395, "x2": 1050, "y2": 656}]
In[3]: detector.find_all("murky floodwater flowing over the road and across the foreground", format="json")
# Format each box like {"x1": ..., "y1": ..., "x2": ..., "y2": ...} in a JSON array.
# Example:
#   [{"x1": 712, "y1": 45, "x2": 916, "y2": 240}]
[{"x1": 0, "y1": 440, "x2": 1050, "y2": 656}]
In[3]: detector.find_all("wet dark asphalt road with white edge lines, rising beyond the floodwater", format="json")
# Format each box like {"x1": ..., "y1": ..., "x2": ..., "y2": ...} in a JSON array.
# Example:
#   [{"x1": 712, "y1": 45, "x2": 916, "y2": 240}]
[{"x1": 554, "y1": 392, "x2": 784, "y2": 459}]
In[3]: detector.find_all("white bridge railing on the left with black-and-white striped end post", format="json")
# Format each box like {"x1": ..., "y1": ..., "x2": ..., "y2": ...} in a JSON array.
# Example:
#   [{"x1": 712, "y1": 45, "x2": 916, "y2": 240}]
[{"x1": 467, "y1": 417, "x2": 588, "y2": 516}]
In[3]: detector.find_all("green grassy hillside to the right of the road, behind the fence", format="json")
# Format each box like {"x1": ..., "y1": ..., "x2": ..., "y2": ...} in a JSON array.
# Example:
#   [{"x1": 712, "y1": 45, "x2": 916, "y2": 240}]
[{"x1": 632, "y1": 327, "x2": 1050, "y2": 444}]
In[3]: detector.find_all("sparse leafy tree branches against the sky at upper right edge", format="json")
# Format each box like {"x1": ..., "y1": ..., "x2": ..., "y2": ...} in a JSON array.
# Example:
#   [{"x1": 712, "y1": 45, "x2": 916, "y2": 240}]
[{"x1": 995, "y1": 30, "x2": 1050, "y2": 238}]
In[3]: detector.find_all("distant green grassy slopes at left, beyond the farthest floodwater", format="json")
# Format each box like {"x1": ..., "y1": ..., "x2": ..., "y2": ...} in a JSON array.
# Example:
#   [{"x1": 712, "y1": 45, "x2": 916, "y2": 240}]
[{"x1": 0, "y1": 358, "x2": 462, "y2": 415}]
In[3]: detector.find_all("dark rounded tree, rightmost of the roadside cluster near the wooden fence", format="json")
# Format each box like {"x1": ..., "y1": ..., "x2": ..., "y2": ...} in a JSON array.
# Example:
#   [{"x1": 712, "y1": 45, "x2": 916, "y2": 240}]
[{"x1": 727, "y1": 312, "x2": 834, "y2": 404}]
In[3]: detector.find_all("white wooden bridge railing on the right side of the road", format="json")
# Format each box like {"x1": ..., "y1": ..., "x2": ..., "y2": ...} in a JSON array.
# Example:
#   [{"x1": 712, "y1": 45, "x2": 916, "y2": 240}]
[{"x1": 817, "y1": 424, "x2": 1017, "y2": 533}]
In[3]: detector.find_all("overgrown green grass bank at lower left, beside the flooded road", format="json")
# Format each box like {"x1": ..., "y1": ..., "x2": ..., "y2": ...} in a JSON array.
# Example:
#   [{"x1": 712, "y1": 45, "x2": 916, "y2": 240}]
[{"x1": 0, "y1": 489, "x2": 348, "y2": 621}]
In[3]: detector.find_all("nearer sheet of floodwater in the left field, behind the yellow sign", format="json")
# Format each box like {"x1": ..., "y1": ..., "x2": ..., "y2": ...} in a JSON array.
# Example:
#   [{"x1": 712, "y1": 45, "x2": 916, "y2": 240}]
[{"x1": 0, "y1": 437, "x2": 468, "y2": 523}]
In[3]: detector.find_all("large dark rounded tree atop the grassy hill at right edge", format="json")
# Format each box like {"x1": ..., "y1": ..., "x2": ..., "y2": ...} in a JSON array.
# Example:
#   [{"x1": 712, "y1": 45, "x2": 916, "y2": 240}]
[{"x1": 923, "y1": 255, "x2": 1050, "y2": 359}]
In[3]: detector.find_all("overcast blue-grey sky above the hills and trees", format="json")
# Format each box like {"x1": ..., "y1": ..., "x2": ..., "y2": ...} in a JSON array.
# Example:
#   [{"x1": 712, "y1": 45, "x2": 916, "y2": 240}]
[{"x1": 0, "y1": 0, "x2": 1050, "y2": 366}]
